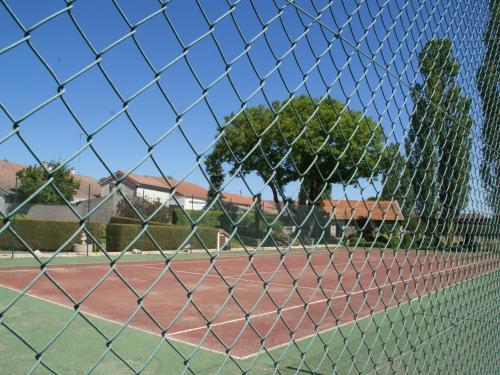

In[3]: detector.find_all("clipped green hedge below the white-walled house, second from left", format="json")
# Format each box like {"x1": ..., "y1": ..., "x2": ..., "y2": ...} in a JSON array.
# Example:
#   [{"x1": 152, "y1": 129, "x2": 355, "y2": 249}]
[{"x1": 106, "y1": 223, "x2": 218, "y2": 251}]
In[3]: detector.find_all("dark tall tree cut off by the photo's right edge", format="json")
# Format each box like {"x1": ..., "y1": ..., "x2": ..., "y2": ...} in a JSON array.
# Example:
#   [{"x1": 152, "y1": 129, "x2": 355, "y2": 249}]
[{"x1": 476, "y1": 0, "x2": 500, "y2": 214}]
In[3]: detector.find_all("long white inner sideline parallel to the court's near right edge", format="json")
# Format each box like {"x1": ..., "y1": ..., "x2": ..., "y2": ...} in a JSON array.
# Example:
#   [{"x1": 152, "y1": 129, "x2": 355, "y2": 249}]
[{"x1": 167, "y1": 264, "x2": 492, "y2": 336}]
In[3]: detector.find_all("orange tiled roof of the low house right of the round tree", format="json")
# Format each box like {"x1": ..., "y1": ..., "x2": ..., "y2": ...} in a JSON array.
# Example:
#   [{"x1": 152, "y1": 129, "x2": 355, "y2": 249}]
[{"x1": 323, "y1": 200, "x2": 403, "y2": 221}]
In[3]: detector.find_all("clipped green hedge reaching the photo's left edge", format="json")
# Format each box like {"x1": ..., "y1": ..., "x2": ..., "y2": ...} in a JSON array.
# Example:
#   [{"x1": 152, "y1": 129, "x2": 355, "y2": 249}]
[{"x1": 0, "y1": 219, "x2": 104, "y2": 251}]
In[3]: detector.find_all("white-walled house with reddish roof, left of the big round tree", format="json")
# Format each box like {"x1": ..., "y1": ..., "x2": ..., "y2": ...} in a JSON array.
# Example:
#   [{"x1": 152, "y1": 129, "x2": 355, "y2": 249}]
[{"x1": 99, "y1": 171, "x2": 208, "y2": 210}]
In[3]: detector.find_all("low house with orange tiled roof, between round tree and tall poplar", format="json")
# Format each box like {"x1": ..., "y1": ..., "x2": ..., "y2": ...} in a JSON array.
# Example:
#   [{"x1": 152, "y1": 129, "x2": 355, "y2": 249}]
[{"x1": 323, "y1": 200, "x2": 403, "y2": 237}]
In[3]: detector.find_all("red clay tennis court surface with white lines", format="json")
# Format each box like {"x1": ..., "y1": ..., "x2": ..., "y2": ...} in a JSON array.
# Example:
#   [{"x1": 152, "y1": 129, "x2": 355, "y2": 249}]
[{"x1": 0, "y1": 250, "x2": 500, "y2": 358}]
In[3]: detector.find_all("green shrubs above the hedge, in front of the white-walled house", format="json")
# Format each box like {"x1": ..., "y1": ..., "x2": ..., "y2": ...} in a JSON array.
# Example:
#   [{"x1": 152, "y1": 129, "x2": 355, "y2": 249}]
[{"x1": 117, "y1": 196, "x2": 177, "y2": 224}]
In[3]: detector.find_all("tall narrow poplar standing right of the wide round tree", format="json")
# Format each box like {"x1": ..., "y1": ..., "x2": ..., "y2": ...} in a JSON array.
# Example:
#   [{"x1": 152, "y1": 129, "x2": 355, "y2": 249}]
[{"x1": 406, "y1": 39, "x2": 472, "y2": 226}]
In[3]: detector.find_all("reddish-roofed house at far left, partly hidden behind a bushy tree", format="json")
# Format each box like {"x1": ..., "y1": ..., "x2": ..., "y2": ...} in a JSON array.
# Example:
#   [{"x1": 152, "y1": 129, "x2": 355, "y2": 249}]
[{"x1": 0, "y1": 160, "x2": 101, "y2": 209}]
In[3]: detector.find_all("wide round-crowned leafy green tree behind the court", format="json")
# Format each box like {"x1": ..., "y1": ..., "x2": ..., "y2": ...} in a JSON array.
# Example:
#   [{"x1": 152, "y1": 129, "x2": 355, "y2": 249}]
[{"x1": 205, "y1": 96, "x2": 384, "y2": 212}]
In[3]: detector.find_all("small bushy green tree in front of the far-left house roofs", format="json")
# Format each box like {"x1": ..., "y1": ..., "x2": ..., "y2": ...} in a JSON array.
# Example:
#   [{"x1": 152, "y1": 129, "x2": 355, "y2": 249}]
[{"x1": 16, "y1": 161, "x2": 80, "y2": 204}]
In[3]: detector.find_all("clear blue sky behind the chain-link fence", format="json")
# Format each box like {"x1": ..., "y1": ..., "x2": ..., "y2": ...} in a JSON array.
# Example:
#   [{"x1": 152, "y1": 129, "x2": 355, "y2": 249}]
[{"x1": 0, "y1": 0, "x2": 487, "y2": 204}]
